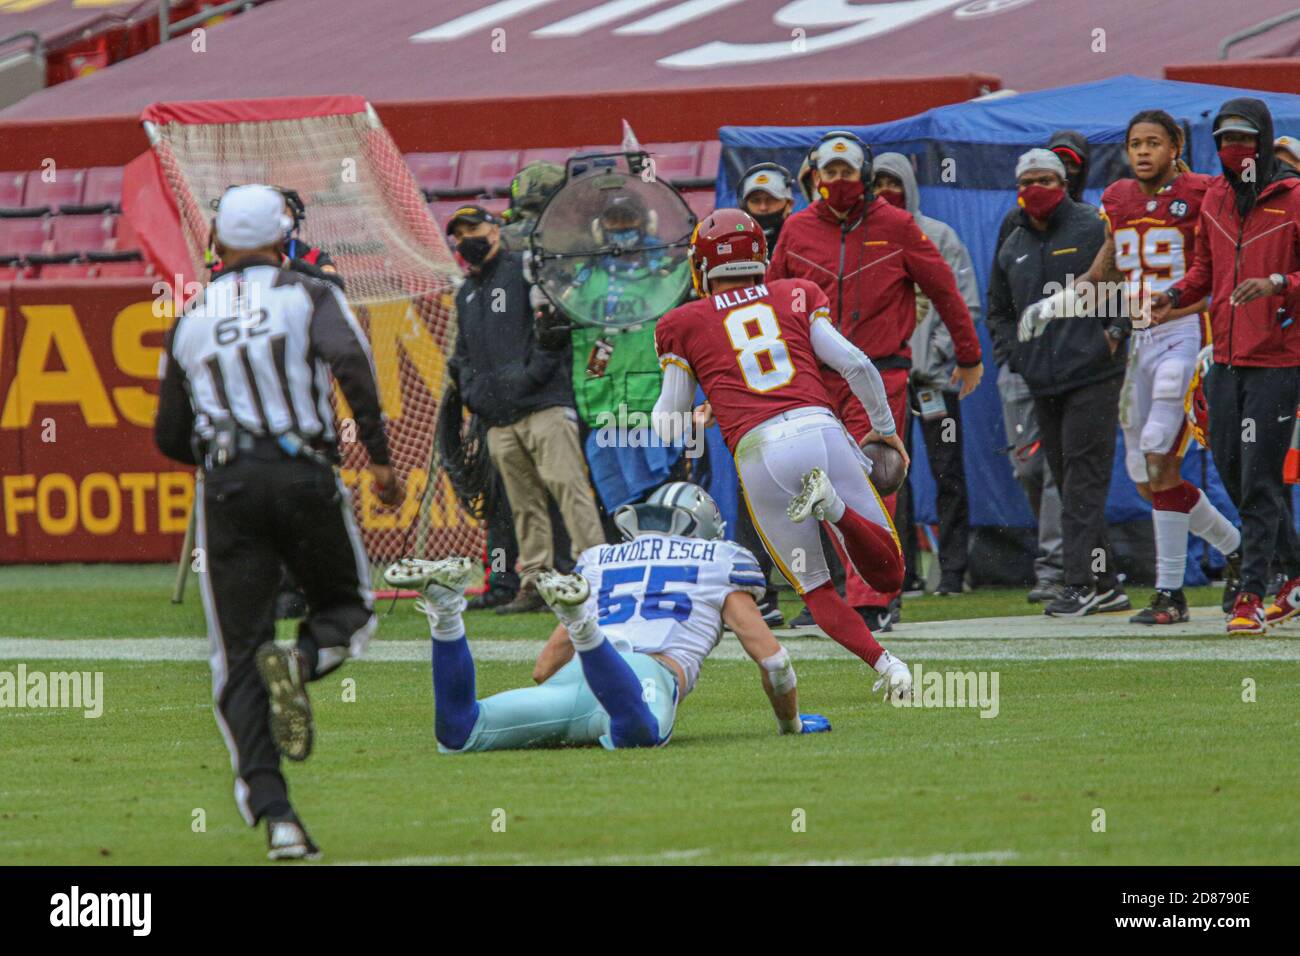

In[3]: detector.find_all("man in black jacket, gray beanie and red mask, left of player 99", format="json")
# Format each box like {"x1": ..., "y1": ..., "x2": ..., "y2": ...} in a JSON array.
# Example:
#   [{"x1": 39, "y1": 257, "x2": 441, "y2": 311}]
[{"x1": 988, "y1": 150, "x2": 1131, "y2": 618}]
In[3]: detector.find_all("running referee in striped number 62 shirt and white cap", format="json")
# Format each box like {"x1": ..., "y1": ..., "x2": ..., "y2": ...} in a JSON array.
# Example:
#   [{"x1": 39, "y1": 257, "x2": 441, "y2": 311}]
[{"x1": 155, "y1": 185, "x2": 403, "y2": 860}]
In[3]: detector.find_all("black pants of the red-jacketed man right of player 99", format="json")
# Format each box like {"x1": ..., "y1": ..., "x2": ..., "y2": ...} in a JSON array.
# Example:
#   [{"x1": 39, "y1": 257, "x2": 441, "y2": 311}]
[{"x1": 1205, "y1": 364, "x2": 1300, "y2": 597}]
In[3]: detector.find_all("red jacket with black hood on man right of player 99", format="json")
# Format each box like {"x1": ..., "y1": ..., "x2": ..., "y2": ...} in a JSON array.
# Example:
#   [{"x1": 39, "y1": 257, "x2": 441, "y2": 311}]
[{"x1": 1170, "y1": 98, "x2": 1300, "y2": 368}]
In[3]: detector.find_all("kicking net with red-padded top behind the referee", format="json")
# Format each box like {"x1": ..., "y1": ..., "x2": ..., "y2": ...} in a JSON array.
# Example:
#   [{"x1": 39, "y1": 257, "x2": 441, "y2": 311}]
[{"x1": 142, "y1": 96, "x2": 484, "y2": 571}]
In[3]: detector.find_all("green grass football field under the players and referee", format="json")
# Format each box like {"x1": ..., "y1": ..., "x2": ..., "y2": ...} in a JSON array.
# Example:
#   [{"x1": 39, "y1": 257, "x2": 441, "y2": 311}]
[{"x1": 0, "y1": 567, "x2": 1300, "y2": 865}]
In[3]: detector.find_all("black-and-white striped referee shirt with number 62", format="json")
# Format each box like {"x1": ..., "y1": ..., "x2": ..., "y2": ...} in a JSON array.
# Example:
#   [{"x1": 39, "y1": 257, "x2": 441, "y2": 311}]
[{"x1": 155, "y1": 264, "x2": 389, "y2": 464}]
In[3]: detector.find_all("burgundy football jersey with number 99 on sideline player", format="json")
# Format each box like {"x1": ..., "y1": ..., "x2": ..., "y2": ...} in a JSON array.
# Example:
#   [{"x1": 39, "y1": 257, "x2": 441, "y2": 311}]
[{"x1": 1101, "y1": 173, "x2": 1212, "y2": 293}]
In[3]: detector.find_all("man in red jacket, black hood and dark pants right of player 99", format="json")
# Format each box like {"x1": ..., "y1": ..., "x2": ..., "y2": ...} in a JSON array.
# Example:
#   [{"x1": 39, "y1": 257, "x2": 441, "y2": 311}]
[{"x1": 1152, "y1": 98, "x2": 1300, "y2": 633}]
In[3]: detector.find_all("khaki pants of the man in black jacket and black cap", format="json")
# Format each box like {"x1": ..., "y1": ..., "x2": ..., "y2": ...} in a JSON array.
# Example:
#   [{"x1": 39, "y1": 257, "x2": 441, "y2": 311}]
[{"x1": 488, "y1": 406, "x2": 605, "y2": 587}]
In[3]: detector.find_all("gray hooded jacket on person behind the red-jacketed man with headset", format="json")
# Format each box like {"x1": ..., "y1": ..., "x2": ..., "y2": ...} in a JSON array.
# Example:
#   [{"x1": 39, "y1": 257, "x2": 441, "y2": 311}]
[{"x1": 874, "y1": 152, "x2": 980, "y2": 392}]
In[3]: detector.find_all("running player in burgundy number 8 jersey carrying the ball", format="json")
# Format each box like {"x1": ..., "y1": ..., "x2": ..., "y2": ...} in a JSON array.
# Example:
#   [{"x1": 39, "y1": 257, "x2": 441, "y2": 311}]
[{"x1": 654, "y1": 209, "x2": 911, "y2": 697}]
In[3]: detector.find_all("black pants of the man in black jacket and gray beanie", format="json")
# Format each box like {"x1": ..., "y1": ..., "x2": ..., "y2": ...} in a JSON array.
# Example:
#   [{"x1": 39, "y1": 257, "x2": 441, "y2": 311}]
[{"x1": 1034, "y1": 375, "x2": 1123, "y2": 591}]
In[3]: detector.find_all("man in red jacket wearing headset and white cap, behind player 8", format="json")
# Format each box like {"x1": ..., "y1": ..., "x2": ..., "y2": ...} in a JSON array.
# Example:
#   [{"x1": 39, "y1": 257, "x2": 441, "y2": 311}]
[{"x1": 767, "y1": 130, "x2": 984, "y2": 631}]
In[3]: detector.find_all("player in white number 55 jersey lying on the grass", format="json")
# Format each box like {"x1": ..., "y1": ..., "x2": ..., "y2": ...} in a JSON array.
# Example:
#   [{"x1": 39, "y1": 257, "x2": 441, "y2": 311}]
[{"x1": 384, "y1": 483, "x2": 831, "y2": 753}]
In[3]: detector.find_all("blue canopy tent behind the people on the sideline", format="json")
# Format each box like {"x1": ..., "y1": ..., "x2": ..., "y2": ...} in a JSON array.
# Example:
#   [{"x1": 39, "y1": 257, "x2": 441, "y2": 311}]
[{"x1": 714, "y1": 75, "x2": 1300, "y2": 584}]
